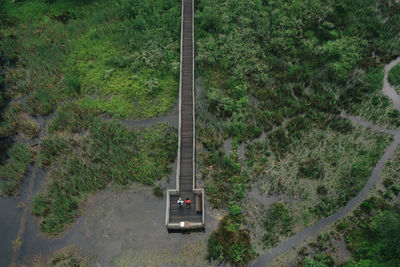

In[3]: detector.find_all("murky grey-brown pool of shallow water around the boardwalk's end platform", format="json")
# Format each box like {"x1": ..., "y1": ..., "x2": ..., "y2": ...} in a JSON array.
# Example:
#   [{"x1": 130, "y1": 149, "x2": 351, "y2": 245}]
[{"x1": 18, "y1": 184, "x2": 220, "y2": 266}]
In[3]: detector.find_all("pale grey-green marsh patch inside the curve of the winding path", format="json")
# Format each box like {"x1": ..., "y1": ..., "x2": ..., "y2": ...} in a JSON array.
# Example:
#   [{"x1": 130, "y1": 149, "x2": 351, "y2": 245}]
[{"x1": 253, "y1": 127, "x2": 390, "y2": 225}]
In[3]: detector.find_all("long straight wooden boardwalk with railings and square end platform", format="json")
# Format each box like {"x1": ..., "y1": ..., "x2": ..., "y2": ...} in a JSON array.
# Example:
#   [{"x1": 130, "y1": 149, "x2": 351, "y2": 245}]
[{"x1": 165, "y1": 0, "x2": 204, "y2": 229}]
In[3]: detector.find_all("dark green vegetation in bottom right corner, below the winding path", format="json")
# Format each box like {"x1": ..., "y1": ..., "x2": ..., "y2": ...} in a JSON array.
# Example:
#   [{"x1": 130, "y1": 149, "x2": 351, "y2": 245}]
[{"x1": 297, "y1": 197, "x2": 400, "y2": 267}]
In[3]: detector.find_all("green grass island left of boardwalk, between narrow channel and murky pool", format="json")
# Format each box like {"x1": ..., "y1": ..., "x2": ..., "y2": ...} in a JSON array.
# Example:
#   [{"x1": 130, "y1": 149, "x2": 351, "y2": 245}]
[{"x1": 32, "y1": 118, "x2": 177, "y2": 236}]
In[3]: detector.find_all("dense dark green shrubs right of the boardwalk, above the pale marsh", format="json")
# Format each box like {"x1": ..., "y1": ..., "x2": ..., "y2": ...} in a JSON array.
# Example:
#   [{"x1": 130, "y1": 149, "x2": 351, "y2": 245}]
[{"x1": 196, "y1": 0, "x2": 400, "y2": 142}]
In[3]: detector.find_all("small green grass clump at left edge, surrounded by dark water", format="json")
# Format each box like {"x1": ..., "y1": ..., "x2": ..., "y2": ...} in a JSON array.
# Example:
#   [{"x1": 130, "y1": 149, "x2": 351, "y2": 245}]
[{"x1": 0, "y1": 144, "x2": 33, "y2": 196}]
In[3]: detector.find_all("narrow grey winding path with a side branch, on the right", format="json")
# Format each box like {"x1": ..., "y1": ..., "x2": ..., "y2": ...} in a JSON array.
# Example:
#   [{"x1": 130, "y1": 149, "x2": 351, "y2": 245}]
[{"x1": 253, "y1": 57, "x2": 400, "y2": 266}]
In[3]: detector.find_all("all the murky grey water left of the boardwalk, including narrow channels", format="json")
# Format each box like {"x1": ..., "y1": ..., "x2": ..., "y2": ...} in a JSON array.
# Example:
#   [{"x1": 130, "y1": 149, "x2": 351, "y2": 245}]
[{"x1": 0, "y1": 99, "x2": 222, "y2": 266}]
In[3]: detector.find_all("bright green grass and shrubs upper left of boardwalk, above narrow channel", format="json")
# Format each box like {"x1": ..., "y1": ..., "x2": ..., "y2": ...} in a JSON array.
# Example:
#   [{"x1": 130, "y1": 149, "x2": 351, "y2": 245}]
[{"x1": 0, "y1": 0, "x2": 181, "y2": 118}]
